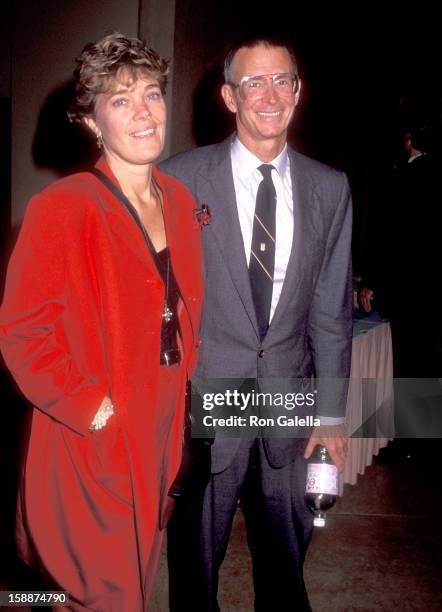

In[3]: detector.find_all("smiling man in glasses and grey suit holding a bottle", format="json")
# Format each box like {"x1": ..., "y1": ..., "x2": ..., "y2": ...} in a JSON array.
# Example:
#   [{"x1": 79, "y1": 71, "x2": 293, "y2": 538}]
[{"x1": 162, "y1": 38, "x2": 352, "y2": 612}]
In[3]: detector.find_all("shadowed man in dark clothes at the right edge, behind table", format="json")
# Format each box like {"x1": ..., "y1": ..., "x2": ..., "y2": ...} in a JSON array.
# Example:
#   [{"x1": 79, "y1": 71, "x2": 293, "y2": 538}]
[{"x1": 359, "y1": 122, "x2": 442, "y2": 450}]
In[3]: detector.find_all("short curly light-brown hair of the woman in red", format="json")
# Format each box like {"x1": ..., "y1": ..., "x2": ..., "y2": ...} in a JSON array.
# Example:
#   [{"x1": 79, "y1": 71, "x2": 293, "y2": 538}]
[{"x1": 68, "y1": 32, "x2": 169, "y2": 121}]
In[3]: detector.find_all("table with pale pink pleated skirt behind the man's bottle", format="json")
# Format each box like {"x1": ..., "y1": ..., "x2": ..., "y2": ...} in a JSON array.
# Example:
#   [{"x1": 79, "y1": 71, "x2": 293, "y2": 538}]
[{"x1": 340, "y1": 313, "x2": 394, "y2": 495}]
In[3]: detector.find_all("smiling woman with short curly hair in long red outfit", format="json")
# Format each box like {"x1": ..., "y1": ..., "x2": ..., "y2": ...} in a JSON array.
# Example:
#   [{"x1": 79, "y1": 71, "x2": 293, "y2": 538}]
[{"x1": 1, "y1": 33, "x2": 202, "y2": 612}]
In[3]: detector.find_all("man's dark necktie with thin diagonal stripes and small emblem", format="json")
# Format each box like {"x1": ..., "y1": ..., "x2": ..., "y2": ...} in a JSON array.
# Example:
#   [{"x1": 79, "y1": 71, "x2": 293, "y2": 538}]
[{"x1": 249, "y1": 164, "x2": 276, "y2": 340}]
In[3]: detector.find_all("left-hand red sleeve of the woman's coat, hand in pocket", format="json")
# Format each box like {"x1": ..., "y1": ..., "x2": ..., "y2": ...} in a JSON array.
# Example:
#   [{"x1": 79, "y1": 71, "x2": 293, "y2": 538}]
[{"x1": 0, "y1": 195, "x2": 108, "y2": 434}]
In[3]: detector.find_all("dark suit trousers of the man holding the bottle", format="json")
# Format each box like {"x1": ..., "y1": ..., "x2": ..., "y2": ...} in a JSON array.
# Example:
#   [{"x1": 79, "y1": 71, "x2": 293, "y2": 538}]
[{"x1": 168, "y1": 438, "x2": 312, "y2": 612}]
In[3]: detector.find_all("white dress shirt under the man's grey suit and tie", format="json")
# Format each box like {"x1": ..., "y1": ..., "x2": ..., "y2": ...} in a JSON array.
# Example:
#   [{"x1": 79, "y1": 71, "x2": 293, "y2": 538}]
[{"x1": 231, "y1": 138, "x2": 293, "y2": 322}]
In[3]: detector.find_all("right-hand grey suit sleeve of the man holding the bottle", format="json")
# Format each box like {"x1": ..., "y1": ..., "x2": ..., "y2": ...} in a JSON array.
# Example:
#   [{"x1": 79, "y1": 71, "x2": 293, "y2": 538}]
[{"x1": 309, "y1": 175, "x2": 352, "y2": 417}]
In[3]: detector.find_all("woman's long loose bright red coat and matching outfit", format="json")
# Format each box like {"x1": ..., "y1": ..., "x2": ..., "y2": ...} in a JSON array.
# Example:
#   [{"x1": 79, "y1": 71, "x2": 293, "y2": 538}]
[{"x1": 0, "y1": 160, "x2": 202, "y2": 612}]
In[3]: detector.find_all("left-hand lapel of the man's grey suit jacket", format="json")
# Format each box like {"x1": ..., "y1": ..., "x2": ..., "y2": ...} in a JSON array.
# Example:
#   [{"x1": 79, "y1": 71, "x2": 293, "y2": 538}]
[{"x1": 198, "y1": 139, "x2": 259, "y2": 337}]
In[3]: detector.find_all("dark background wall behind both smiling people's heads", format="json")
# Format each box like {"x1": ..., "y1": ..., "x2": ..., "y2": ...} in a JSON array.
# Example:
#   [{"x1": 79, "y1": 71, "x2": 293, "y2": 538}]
[{"x1": 4, "y1": 0, "x2": 441, "y2": 253}]
